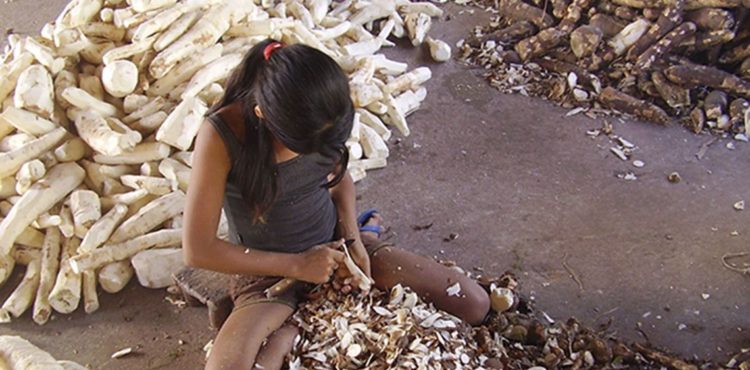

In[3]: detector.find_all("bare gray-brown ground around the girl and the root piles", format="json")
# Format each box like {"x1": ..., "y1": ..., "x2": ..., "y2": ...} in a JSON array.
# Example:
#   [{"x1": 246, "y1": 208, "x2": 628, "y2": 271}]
[{"x1": 0, "y1": 0, "x2": 750, "y2": 369}]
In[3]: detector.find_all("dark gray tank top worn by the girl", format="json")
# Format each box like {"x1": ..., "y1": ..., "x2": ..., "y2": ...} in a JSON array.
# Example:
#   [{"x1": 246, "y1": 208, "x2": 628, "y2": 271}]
[{"x1": 208, "y1": 113, "x2": 337, "y2": 253}]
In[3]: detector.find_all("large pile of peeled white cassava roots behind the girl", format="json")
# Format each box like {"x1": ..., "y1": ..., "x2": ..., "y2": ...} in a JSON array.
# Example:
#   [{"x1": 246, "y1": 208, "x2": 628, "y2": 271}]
[{"x1": 0, "y1": 0, "x2": 450, "y2": 324}]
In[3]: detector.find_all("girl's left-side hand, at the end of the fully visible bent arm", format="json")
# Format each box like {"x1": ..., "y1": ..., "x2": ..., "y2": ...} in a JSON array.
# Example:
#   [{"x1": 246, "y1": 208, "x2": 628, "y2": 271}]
[{"x1": 292, "y1": 240, "x2": 346, "y2": 284}]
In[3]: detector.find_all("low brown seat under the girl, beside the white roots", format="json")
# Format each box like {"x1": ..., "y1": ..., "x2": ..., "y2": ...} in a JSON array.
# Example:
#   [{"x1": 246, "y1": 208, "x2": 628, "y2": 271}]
[{"x1": 173, "y1": 267, "x2": 233, "y2": 330}]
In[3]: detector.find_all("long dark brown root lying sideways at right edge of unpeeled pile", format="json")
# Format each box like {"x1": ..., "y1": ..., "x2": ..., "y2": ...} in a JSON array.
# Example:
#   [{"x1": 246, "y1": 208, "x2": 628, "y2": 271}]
[{"x1": 664, "y1": 65, "x2": 750, "y2": 97}]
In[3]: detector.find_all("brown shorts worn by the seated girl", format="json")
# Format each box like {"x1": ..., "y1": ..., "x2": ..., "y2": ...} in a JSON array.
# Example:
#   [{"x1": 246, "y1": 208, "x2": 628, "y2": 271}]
[{"x1": 229, "y1": 242, "x2": 393, "y2": 310}]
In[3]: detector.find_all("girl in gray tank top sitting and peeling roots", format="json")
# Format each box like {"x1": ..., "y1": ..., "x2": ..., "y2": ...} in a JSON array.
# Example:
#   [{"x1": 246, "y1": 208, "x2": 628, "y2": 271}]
[{"x1": 183, "y1": 40, "x2": 489, "y2": 369}]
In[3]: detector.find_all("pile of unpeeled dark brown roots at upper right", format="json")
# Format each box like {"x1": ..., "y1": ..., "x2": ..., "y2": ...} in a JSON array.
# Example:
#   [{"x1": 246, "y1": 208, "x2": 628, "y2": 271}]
[{"x1": 462, "y1": 0, "x2": 750, "y2": 135}]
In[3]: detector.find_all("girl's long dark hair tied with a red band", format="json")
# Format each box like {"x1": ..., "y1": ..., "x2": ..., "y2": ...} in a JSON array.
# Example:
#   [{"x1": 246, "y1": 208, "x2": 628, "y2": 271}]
[{"x1": 208, "y1": 39, "x2": 354, "y2": 222}]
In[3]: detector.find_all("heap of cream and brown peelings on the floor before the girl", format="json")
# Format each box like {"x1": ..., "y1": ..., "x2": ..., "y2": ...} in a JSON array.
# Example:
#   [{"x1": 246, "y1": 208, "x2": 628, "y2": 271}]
[{"x1": 288, "y1": 274, "x2": 716, "y2": 370}]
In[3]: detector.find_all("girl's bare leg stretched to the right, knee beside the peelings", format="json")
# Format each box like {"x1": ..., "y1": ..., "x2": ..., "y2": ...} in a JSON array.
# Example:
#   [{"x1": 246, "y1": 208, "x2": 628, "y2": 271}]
[{"x1": 361, "y1": 213, "x2": 490, "y2": 325}]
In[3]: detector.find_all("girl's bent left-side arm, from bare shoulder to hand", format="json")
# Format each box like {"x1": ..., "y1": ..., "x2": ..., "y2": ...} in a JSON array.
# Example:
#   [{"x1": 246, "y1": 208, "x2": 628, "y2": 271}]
[{"x1": 182, "y1": 122, "x2": 342, "y2": 282}]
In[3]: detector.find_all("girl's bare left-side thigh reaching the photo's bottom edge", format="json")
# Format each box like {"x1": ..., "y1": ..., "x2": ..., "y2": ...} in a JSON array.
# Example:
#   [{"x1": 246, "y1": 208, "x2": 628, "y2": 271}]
[{"x1": 206, "y1": 303, "x2": 294, "y2": 370}]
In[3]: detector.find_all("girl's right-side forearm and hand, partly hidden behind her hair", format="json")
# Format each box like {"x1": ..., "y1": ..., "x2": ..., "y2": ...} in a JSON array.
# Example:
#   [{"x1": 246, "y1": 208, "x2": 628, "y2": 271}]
[{"x1": 331, "y1": 171, "x2": 372, "y2": 276}]
